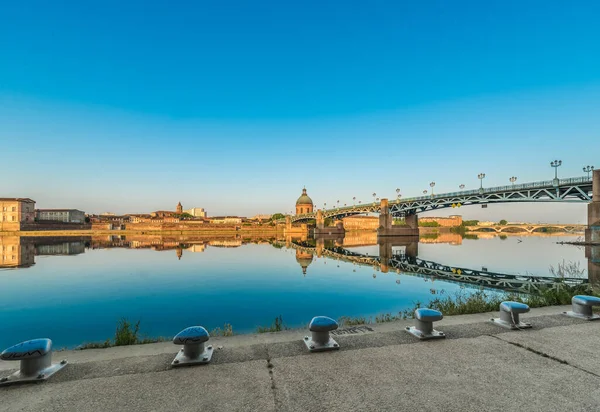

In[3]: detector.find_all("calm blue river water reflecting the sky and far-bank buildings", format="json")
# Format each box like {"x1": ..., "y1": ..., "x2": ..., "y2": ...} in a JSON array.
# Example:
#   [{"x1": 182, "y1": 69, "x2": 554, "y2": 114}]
[{"x1": 0, "y1": 236, "x2": 588, "y2": 348}]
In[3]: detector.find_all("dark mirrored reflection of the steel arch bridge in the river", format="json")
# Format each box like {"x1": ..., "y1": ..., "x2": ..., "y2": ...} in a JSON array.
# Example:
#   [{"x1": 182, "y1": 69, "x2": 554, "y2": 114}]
[{"x1": 280, "y1": 242, "x2": 589, "y2": 293}]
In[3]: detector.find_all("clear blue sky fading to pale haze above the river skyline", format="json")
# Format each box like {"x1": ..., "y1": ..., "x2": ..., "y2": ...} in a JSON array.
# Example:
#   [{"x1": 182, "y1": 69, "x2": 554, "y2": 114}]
[{"x1": 0, "y1": 0, "x2": 600, "y2": 222}]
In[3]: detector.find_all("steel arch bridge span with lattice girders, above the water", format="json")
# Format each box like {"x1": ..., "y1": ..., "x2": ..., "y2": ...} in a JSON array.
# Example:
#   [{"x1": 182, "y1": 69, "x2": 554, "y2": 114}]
[{"x1": 280, "y1": 176, "x2": 592, "y2": 223}]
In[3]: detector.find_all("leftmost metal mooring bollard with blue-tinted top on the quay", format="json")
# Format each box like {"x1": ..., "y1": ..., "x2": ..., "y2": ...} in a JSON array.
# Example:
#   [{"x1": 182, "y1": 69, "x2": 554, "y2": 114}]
[{"x1": 0, "y1": 338, "x2": 67, "y2": 386}]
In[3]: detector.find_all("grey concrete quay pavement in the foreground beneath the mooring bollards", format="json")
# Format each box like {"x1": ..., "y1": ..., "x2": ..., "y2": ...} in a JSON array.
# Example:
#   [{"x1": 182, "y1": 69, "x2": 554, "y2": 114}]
[{"x1": 0, "y1": 306, "x2": 600, "y2": 412}]
